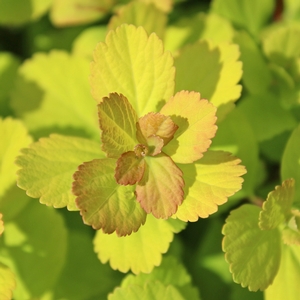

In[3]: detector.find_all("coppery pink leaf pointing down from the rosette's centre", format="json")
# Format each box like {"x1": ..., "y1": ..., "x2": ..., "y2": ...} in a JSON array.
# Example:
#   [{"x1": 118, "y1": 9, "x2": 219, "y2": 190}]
[{"x1": 135, "y1": 153, "x2": 184, "y2": 219}]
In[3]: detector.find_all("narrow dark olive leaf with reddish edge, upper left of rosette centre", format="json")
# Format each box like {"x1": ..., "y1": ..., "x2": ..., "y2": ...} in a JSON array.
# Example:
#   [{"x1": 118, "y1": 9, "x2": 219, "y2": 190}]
[{"x1": 98, "y1": 93, "x2": 138, "y2": 158}]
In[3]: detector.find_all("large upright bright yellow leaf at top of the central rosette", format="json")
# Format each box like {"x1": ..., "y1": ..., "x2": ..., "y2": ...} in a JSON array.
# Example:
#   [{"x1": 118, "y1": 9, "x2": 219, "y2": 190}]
[{"x1": 90, "y1": 25, "x2": 175, "y2": 117}]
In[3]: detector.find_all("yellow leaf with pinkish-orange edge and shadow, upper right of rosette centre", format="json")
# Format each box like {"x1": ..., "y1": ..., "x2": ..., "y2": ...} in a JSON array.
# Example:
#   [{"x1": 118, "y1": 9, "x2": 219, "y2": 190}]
[{"x1": 160, "y1": 91, "x2": 217, "y2": 163}]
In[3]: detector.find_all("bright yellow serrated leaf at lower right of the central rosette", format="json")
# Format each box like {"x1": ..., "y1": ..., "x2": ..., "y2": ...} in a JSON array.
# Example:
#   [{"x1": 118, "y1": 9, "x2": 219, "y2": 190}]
[{"x1": 176, "y1": 151, "x2": 246, "y2": 222}]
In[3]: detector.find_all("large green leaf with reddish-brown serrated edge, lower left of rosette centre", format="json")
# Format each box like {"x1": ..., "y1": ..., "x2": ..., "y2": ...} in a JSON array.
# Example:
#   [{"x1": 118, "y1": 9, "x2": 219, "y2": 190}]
[{"x1": 73, "y1": 158, "x2": 146, "y2": 236}]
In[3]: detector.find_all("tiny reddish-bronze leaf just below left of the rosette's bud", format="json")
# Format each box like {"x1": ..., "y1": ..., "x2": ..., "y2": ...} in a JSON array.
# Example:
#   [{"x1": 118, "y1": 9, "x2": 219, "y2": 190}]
[{"x1": 115, "y1": 151, "x2": 145, "y2": 185}]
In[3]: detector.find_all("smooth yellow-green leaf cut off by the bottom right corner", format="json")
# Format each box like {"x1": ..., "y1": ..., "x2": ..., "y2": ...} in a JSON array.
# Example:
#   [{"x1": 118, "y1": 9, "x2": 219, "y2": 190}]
[{"x1": 265, "y1": 245, "x2": 300, "y2": 300}]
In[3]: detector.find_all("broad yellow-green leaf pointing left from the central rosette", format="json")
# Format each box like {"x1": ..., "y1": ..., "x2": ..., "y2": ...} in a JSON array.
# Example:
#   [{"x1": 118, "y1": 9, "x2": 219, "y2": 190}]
[{"x1": 16, "y1": 134, "x2": 104, "y2": 210}]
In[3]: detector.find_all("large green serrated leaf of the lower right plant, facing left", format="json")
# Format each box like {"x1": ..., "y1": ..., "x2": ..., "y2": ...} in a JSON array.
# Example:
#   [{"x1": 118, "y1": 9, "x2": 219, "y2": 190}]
[{"x1": 222, "y1": 204, "x2": 281, "y2": 291}]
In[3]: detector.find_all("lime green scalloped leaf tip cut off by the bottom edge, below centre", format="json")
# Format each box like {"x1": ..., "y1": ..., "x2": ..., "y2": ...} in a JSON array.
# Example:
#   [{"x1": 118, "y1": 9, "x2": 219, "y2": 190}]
[{"x1": 108, "y1": 281, "x2": 185, "y2": 300}]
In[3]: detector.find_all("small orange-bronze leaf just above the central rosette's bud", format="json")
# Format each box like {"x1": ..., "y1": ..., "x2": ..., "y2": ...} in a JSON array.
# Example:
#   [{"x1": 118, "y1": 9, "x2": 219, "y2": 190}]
[{"x1": 136, "y1": 112, "x2": 178, "y2": 146}]
